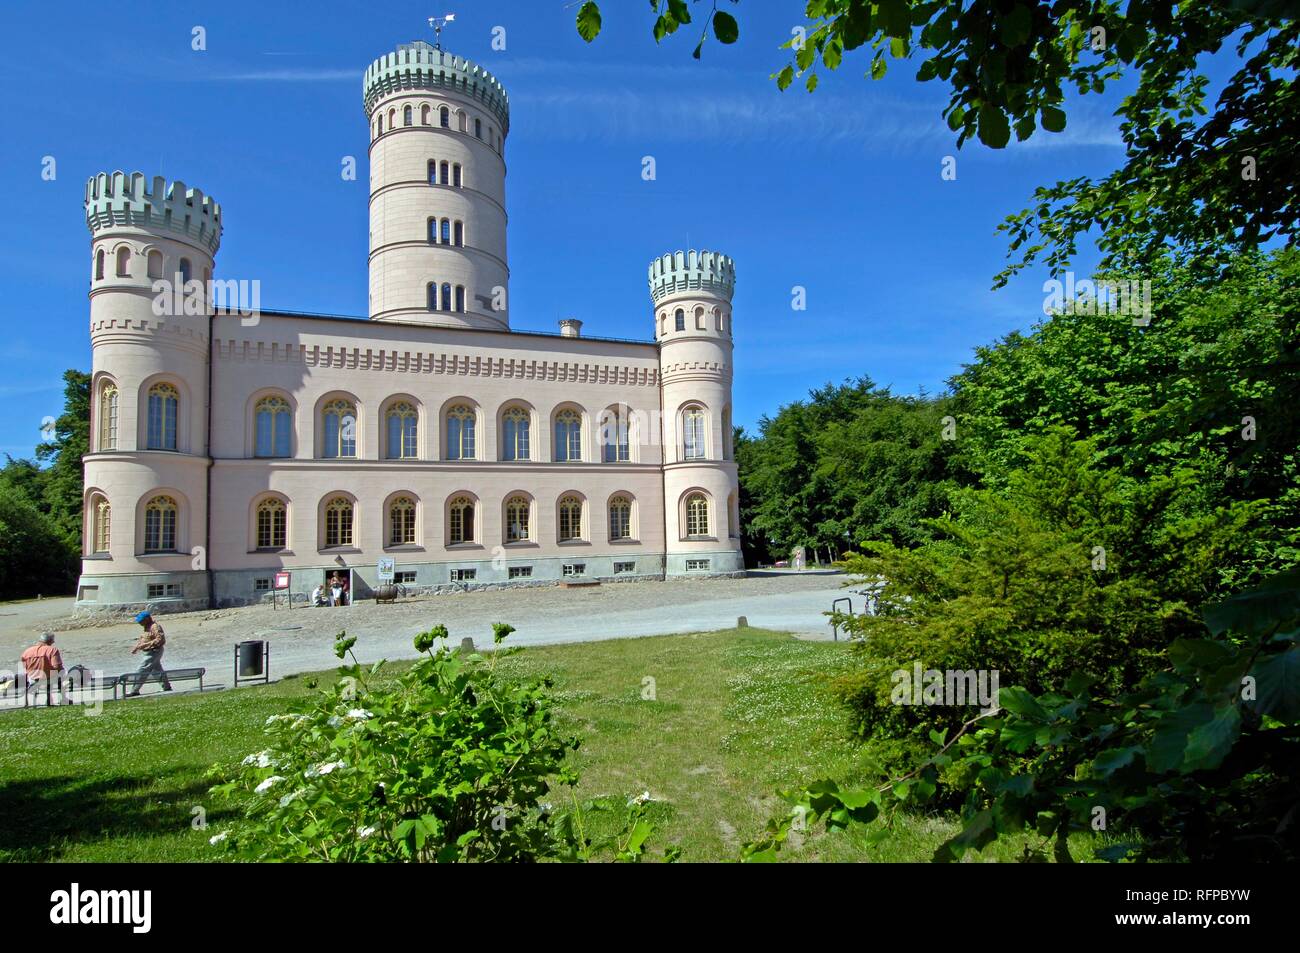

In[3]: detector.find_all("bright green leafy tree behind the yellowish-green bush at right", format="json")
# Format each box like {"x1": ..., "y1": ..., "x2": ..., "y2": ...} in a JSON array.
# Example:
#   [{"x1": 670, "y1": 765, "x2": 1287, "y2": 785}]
[{"x1": 950, "y1": 251, "x2": 1300, "y2": 582}]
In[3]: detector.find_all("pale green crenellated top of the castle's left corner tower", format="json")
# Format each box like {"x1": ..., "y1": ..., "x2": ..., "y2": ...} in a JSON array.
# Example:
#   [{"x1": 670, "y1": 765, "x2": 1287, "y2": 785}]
[{"x1": 85, "y1": 172, "x2": 221, "y2": 255}]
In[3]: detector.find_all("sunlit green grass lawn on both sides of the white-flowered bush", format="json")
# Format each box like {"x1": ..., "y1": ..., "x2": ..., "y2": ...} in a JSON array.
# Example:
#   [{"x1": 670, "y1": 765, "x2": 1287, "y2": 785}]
[{"x1": 0, "y1": 629, "x2": 1079, "y2": 862}]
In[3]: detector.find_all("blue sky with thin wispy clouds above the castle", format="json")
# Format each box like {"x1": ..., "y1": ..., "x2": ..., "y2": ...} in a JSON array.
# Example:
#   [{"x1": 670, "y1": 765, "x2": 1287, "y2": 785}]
[{"x1": 0, "y1": 0, "x2": 1122, "y2": 456}]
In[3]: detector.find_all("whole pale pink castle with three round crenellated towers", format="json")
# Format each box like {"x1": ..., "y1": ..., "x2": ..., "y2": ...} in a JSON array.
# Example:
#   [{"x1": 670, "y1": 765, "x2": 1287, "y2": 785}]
[{"x1": 78, "y1": 42, "x2": 744, "y2": 611}]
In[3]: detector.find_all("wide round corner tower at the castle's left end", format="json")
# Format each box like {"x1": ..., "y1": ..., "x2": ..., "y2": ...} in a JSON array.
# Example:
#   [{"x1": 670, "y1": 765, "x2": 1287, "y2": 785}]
[{"x1": 78, "y1": 172, "x2": 221, "y2": 608}]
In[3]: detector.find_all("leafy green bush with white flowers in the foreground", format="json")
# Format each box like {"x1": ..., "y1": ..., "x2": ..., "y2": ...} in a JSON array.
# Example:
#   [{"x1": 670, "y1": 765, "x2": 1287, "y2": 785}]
[{"x1": 212, "y1": 624, "x2": 582, "y2": 862}]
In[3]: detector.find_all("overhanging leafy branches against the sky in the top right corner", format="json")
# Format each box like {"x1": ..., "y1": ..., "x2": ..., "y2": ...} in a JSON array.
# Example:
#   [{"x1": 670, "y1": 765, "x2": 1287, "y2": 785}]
[{"x1": 577, "y1": 0, "x2": 1300, "y2": 285}]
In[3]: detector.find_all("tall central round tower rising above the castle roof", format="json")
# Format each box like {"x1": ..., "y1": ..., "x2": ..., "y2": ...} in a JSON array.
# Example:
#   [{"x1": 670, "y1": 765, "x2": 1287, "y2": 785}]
[{"x1": 363, "y1": 40, "x2": 510, "y2": 329}]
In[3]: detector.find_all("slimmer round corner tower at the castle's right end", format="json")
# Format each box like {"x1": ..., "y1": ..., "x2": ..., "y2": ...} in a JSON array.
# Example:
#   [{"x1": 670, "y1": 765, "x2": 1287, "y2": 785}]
[{"x1": 649, "y1": 251, "x2": 745, "y2": 576}]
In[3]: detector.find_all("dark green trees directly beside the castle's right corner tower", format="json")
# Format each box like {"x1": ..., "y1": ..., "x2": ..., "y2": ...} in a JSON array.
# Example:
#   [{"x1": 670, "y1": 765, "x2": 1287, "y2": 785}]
[{"x1": 736, "y1": 377, "x2": 956, "y2": 558}]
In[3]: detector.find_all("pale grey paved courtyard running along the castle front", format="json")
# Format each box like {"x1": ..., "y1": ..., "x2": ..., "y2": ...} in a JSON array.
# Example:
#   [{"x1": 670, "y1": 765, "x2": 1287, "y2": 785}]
[{"x1": 0, "y1": 572, "x2": 861, "y2": 692}]
